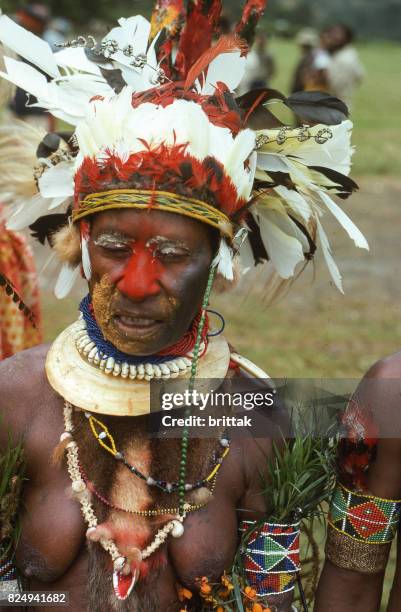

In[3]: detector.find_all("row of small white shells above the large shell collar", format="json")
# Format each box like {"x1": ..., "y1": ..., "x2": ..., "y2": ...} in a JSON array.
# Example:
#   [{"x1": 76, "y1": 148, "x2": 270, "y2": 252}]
[{"x1": 73, "y1": 315, "x2": 205, "y2": 381}]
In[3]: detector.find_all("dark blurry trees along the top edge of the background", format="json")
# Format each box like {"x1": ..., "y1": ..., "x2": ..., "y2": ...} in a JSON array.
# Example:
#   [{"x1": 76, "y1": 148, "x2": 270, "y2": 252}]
[{"x1": 1, "y1": 0, "x2": 401, "y2": 40}]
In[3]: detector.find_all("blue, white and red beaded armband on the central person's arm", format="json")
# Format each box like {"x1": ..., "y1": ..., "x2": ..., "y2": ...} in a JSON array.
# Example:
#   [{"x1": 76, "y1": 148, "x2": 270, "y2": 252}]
[{"x1": 240, "y1": 521, "x2": 300, "y2": 597}]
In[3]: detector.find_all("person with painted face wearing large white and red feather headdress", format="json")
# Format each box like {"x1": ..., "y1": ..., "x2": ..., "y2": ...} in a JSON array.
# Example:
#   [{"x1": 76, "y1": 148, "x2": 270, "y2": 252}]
[{"x1": 0, "y1": 0, "x2": 367, "y2": 612}]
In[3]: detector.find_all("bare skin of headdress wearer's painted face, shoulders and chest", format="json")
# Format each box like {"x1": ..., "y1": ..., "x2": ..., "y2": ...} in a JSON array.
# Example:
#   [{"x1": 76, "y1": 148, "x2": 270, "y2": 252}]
[{"x1": 0, "y1": 211, "x2": 291, "y2": 612}]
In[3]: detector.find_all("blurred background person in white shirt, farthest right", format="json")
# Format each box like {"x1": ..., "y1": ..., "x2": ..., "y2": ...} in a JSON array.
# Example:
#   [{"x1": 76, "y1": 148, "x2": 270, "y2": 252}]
[{"x1": 323, "y1": 23, "x2": 365, "y2": 108}]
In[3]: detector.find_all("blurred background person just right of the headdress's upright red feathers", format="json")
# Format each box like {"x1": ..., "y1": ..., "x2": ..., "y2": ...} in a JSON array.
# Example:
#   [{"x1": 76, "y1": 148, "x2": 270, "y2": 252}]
[{"x1": 238, "y1": 33, "x2": 276, "y2": 95}]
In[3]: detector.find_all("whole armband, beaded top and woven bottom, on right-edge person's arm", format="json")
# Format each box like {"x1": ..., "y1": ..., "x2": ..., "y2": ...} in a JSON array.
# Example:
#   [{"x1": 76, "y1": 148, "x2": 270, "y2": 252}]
[{"x1": 326, "y1": 484, "x2": 401, "y2": 574}]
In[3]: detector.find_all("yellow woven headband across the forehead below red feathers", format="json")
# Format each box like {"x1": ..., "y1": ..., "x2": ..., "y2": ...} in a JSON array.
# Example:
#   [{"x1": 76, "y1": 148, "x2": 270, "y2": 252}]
[{"x1": 72, "y1": 189, "x2": 233, "y2": 240}]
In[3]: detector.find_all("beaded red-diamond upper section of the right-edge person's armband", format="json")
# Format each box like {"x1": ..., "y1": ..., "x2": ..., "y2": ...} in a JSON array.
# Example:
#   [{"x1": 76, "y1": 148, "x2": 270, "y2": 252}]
[{"x1": 329, "y1": 484, "x2": 401, "y2": 545}]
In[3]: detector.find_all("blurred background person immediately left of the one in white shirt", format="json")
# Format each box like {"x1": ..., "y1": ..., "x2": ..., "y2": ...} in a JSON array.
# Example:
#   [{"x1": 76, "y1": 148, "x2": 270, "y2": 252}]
[{"x1": 291, "y1": 28, "x2": 331, "y2": 93}]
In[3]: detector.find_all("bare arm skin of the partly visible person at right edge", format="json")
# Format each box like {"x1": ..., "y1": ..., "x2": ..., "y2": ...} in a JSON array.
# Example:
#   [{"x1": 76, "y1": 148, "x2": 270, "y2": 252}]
[{"x1": 315, "y1": 352, "x2": 401, "y2": 612}]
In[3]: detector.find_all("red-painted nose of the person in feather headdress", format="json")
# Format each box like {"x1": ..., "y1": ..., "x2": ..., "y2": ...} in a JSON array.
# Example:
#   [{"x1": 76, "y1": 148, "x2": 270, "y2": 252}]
[{"x1": 117, "y1": 248, "x2": 162, "y2": 300}]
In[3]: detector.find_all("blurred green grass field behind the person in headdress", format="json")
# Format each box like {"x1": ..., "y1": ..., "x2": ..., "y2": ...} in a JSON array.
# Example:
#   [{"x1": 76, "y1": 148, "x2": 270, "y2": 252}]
[{"x1": 37, "y1": 40, "x2": 401, "y2": 610}]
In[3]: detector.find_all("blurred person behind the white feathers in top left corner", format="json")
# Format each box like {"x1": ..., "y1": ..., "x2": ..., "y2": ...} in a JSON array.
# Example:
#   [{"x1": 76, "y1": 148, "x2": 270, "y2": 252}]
[{"x1": 10, "y1": 4, "x2": 53, "y2": 131}]
